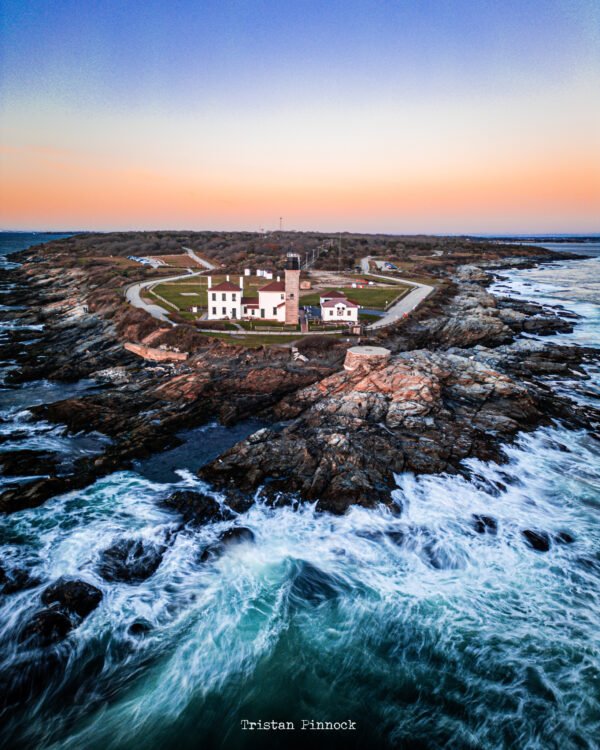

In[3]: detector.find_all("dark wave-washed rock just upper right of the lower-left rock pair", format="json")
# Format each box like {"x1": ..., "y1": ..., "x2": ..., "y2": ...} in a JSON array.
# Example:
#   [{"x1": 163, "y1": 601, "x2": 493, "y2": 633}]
[{"x1": 98, "y1": 539, "x2": 166, "y2": 583}]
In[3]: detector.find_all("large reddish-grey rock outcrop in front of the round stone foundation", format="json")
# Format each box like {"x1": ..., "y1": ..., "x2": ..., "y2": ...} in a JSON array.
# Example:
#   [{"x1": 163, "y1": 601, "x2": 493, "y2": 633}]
[{"x1": 200, "y1": 351, "x2": 544, "y2": 513}]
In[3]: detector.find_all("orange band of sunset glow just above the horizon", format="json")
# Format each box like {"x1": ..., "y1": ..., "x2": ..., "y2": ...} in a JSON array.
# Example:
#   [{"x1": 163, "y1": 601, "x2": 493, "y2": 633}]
[{"x1": 0, "y1": 144, "x2": 600, "y2": 232}]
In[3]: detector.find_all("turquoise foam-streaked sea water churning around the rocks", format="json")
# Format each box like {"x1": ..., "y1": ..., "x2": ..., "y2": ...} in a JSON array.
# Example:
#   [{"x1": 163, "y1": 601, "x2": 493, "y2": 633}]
[{"x1": 0, "y1": 236, "x2": 600, "y2": 750}]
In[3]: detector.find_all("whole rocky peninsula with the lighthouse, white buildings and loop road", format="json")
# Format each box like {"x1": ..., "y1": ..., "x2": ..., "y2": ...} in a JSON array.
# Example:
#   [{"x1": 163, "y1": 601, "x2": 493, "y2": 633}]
[{"x1": 0, "y1": 232, "x2": 594, "y2": 514}]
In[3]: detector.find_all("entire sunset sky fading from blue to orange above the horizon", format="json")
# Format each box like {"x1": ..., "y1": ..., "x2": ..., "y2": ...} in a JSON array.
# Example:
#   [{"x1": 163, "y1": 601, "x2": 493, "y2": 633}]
[{"x1": 0, "y1": 0, "x2": 600, "y2": 233}]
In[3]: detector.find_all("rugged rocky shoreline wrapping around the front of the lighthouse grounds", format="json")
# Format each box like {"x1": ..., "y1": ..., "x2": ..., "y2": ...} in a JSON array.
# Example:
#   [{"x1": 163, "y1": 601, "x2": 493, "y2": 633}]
[{"x1": 0, "y1": 238, "x2": 598, "y2": 513}]
